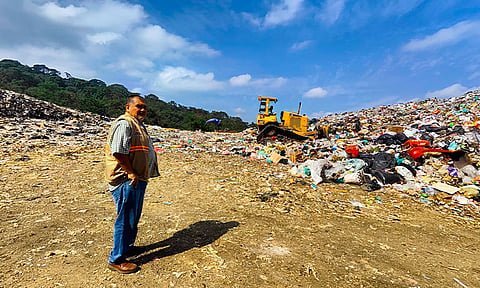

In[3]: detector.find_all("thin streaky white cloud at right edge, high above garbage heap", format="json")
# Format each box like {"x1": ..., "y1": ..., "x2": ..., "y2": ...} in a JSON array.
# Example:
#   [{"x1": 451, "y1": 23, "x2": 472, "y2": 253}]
[{"x1": 403, "y1": 21, "x2": 480, "y2": 52}]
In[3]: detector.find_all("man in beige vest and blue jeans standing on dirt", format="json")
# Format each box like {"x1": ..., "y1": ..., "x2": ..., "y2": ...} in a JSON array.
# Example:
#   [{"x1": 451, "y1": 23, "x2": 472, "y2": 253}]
[{"x1": 105, "y1": 95, "x2": 159, "y2": 274}]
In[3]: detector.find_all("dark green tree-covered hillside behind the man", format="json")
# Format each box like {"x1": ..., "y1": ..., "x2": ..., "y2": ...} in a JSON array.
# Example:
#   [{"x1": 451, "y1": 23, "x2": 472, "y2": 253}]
[{"x1": 0, "y1": 59, "x2": 248, "y2": 131}]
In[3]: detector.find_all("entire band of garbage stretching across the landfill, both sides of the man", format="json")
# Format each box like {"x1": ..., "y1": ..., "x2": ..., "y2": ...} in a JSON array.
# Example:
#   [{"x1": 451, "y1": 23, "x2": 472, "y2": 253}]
[{"x1": 0, "y1": 90, "x2": 480, "y2": 210}]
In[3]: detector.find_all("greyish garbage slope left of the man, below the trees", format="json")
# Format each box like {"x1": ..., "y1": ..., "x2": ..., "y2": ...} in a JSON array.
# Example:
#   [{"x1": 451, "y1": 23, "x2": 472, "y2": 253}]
[{"x1": 0, "y1": 90, "x2": 107, "y2": 152}]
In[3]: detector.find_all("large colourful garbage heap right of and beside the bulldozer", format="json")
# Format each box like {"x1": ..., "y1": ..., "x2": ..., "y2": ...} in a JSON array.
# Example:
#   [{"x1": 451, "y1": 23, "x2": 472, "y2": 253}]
[{"x1": 251, "y1": 90, "x2": 480, "y2": 209}]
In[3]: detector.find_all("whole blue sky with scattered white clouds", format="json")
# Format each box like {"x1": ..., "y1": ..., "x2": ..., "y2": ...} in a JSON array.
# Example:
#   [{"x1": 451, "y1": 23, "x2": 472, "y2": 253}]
[{"x1": 0, "y1": 0, "x2": 480, "y2": 122}]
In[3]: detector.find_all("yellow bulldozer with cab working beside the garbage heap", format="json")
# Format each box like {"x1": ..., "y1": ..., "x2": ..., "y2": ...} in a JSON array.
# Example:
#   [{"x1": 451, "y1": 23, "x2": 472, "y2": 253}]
[{"x1": 257, "y1": 96, "x2": 328, "y2": 142}]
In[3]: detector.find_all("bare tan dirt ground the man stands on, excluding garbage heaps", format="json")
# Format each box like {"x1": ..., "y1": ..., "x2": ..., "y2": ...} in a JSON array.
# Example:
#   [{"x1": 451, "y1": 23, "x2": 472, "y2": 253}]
[{"x1": 0, "y1": 145, "x2": 480, "y2": 287}]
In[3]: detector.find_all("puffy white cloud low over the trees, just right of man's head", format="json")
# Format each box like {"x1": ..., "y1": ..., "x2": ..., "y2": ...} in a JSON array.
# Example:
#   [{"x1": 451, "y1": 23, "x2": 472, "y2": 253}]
[{"x1": 152, "y1": 66, "x2": 224, "y2": 91}]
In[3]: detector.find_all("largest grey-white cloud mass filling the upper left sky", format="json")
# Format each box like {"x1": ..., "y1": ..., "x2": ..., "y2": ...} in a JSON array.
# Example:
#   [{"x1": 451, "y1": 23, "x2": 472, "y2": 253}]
[{"x1": 0, "y1": 0, "x2": 220, "y2": 83}]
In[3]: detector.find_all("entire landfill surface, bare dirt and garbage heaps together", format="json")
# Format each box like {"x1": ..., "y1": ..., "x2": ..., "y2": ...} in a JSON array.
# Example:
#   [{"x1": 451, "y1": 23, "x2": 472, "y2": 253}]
[{"x1": 0, "y1": 90, "x2": 480, "y2": 287}]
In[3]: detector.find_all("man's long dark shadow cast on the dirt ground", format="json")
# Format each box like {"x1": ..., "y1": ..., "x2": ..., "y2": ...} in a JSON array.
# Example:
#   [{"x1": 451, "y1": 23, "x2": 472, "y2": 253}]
[{"x1": 130, "y1": 220, "x2": 240, "y2": 265}]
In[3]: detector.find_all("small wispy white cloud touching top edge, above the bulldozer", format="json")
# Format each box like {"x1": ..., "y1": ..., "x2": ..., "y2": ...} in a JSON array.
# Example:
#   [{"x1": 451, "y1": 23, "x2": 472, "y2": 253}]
[{"x1": 263, "y1": 0, "x2": 303, "y2": 27}]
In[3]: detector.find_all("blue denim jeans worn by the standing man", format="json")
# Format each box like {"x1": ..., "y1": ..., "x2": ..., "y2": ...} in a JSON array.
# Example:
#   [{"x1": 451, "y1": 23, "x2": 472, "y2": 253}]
[{"x1": 108, "y1": 180, "x2": 147, "y2": 264}]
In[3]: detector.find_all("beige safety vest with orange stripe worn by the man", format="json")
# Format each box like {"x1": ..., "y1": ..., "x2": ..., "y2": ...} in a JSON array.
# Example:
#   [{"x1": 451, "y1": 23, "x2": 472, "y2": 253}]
[{"x1": 105, "y1": 113, "x2": 158, "y2": 186}]
